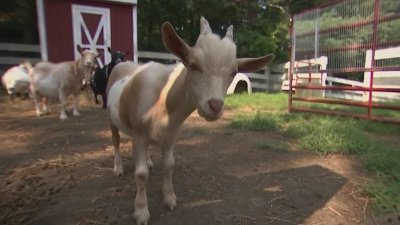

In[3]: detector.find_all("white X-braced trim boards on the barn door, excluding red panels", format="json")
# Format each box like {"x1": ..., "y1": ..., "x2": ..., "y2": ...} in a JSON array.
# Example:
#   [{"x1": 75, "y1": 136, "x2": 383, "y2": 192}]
[{"x1": 71, "y1": 4, "x2": 111, "y2": 67}]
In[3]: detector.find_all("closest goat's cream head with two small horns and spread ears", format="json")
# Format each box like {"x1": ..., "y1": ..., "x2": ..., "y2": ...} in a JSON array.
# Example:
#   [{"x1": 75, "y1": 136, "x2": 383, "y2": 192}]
[{"x1": 162, "y1": 17, "x2": 274, "y2": 121}]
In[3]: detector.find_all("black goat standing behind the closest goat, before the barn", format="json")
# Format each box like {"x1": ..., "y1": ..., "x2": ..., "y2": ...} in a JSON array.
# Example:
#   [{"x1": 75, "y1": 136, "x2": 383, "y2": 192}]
[{"x1": 90, "y1": 47, "x2": 129, "y2": 108}]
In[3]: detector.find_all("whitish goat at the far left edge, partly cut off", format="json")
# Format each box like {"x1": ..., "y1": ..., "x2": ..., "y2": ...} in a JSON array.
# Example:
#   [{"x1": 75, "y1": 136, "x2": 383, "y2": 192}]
[{"x1": 1, "y1": 62, "x2": 32, "y2": 102}]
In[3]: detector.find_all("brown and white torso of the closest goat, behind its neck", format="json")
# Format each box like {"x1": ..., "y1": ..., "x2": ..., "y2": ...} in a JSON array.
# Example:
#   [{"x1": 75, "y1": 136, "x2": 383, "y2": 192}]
[{"x1": 107, "y1": 62, "x2": 174, "y2": 134}]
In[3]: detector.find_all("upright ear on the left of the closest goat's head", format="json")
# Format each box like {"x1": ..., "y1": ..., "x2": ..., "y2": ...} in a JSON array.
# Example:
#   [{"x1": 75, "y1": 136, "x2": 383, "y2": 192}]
[{"x1": 161, "y1": 22, "x2": 190, "y2": 64}]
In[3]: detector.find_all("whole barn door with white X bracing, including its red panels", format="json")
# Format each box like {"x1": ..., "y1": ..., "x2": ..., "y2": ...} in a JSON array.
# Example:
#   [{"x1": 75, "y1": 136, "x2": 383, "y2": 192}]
[{"x1": 72, "y1": 4, "x2": 111, "y2": 67}]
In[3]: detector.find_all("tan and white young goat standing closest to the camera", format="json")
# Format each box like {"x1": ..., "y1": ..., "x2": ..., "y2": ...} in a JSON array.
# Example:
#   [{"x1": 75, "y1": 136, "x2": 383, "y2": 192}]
[{"x1": 107, "y1": 17, "x2": 274, "y2": 225}]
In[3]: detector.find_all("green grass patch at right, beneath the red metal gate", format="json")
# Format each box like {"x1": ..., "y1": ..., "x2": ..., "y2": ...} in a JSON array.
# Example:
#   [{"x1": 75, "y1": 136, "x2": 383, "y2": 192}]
[{"x1": 227, "y1": 93, "x2": 400, "y2": 213}]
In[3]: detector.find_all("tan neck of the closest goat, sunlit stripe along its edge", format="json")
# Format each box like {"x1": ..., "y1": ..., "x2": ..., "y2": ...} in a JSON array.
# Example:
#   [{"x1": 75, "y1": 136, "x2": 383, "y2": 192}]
[{"x1": 162, "y1": 64, "x2": 196, "y2": 124}]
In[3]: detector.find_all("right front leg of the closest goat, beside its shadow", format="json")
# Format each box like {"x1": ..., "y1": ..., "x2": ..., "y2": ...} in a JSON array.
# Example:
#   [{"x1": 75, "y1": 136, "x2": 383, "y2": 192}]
[{"x1": 162, "y1": 141, "x2": 176, "y2": 210}]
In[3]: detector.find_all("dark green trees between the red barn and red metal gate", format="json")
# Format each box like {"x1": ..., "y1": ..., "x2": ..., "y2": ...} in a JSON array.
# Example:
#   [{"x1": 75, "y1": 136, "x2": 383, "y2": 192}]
[{"x1": 138, "y1": 0, "x2": 329, "y2": 63}]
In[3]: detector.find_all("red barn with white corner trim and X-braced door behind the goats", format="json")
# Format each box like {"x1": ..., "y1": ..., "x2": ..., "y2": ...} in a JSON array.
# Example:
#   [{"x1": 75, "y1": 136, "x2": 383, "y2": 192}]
[{"x1": 36, "y1": 0, "x2": 137, "y2": 66}]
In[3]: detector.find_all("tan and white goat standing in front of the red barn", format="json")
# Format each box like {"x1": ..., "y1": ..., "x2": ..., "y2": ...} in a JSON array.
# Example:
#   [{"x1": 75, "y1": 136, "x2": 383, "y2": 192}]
[{"x1": 31, "y1": 45, "x2": 97, "y2": 120}]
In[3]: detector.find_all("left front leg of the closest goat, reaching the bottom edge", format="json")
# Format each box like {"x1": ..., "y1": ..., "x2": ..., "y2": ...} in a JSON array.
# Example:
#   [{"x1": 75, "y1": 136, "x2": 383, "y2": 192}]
[{"x1": 132, "y1": 138, "x2": 150, "y2": 225}]
